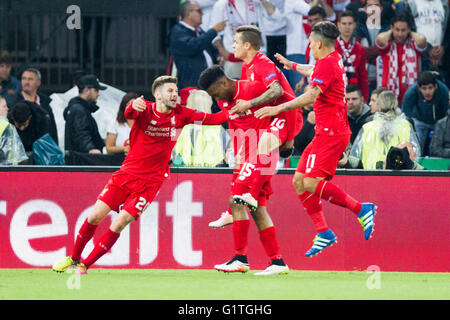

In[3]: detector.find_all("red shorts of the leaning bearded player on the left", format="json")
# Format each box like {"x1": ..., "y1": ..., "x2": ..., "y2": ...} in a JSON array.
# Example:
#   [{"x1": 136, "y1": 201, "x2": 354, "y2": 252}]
[{"x1": 97, "y1": 170, "x2": 162, "y2": 220}]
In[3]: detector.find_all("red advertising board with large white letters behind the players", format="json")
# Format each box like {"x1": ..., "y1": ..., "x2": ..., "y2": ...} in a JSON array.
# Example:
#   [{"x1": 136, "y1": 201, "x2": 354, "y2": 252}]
[{"x1": 0, "y1": 168, "x2": 450, "y2": 272}]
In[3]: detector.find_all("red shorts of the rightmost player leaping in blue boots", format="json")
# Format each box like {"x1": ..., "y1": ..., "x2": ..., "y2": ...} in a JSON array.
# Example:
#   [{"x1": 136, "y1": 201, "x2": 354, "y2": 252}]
[{"x1": 296, "y1": 135, "x2": 350, "y2": 180}]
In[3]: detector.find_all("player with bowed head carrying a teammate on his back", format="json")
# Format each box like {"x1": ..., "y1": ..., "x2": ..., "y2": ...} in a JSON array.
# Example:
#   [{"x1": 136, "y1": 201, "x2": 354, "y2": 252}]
[{"x1": 198, "y1": 65, "x2": 289, "y2": 275}]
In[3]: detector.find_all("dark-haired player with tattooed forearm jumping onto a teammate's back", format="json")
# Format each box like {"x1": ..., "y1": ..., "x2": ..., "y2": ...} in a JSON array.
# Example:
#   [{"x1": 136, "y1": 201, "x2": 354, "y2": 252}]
[{"x1": 207, "y1": 25, "x2": 303, "y2": 229}]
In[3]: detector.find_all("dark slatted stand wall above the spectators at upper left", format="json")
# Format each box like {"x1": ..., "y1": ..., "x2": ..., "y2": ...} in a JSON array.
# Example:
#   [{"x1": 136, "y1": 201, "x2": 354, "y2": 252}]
[{"x1": 0, "y1": 0, "x2": 179, "y2": 95}]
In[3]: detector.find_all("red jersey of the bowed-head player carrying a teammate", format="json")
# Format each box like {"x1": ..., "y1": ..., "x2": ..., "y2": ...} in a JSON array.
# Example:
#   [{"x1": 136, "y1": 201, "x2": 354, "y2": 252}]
[{"x1": 217, "y1": 80, "x2": 271, "y2": 161}]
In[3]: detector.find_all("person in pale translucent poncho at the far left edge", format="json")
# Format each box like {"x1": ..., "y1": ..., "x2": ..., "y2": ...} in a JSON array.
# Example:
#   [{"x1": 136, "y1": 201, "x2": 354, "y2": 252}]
[{"x1": 0, "y1": 96, "x2": 28, "y2": 165}]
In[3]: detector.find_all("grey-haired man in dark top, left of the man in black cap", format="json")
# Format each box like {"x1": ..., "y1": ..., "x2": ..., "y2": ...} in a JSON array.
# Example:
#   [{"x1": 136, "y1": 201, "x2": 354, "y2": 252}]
[{"x1": 7, "y1": 68, "x2": 58, "y2": 144}]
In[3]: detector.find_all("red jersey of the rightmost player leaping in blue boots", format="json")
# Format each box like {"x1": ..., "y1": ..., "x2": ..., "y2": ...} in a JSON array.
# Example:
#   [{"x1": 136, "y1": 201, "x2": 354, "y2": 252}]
[{"x1": 311, "y1": 51, "x2": 351, "y2": 136}]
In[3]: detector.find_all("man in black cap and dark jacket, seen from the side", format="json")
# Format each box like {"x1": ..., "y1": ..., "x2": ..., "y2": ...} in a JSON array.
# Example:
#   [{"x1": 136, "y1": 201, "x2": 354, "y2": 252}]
[{"x1": 63, "y1": 75, "x2": 106, "y2": 154}]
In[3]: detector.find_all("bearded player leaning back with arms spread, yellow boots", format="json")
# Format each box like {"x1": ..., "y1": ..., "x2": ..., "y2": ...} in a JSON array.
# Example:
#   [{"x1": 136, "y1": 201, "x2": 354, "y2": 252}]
[{"x1": 53, "y1": 76, "x2": 227, "y2": 274}]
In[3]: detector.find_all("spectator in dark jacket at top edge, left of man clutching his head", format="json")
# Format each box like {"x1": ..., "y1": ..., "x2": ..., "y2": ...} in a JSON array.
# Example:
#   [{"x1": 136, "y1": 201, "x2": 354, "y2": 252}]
[{"x1": 347, "y1": 0, "x2": 394, "y2": 92}]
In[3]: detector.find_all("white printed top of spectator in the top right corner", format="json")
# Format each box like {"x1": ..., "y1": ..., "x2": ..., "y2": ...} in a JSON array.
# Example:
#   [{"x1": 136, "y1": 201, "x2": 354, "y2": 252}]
[{"x1": 406, "y1": 0, "x2": 449, "y2": 71}]
